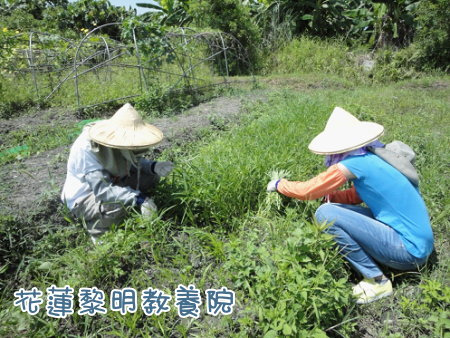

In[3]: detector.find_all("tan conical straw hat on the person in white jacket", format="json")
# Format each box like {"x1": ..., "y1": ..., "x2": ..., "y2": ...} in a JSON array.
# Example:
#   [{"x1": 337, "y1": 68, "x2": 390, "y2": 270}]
[{"x1": 89, "y1": 103, "x2": 163, "y2": 150}]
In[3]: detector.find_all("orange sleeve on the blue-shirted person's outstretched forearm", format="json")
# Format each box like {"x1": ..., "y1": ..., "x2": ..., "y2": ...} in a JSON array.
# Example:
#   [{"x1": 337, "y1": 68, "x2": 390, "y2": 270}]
[{"x1": 277, "y1": 164, "x2": 347, "y2": 200}]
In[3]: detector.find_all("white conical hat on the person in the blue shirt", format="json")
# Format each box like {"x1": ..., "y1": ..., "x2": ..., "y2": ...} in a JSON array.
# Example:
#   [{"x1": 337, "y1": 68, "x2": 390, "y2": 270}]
[{"x1": 308, "y1": 107, "x2": 384, "y2": 155}]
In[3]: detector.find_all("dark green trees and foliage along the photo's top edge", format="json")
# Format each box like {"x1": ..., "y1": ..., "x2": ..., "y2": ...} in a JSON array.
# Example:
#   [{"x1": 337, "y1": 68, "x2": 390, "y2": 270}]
[{"x1": 0, "y1": 0, "x2": 450, "y2": 70}]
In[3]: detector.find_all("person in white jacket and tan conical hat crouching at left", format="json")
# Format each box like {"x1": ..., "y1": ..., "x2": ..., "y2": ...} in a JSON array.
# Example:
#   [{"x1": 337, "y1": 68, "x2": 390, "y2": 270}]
[{"x1": 61, "y1": 103, "x2": 173, "y2": 243}]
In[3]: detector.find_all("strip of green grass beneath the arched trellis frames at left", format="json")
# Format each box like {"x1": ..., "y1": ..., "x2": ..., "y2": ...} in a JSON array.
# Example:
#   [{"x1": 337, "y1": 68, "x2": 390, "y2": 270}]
[{"x1": 0, "y1": 45, "x2": 229, "y2": 118}]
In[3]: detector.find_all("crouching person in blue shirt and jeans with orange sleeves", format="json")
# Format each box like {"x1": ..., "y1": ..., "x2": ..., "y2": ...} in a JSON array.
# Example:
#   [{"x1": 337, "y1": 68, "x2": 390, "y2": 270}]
[{"x1": 267, "y1": 107, "x2": 433, "y2": 304}]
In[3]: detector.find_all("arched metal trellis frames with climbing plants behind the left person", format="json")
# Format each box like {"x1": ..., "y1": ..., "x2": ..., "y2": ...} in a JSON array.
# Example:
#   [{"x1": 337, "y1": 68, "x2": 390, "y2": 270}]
[{"x1": 0, "y1": 23, "x2": 252, "y2": 108}]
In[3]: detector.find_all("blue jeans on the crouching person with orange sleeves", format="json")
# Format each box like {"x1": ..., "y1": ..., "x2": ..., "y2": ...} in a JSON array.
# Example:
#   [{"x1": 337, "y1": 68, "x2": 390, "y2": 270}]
[{"x1": 316, "y1": 203, "x2": 427, "y2": 278}]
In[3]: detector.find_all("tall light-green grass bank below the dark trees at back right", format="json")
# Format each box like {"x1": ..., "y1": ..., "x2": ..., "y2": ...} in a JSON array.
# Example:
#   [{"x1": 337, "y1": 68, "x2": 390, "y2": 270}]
[{"x1": 263, "y1": 36, "x2": 440, "y2": 84}]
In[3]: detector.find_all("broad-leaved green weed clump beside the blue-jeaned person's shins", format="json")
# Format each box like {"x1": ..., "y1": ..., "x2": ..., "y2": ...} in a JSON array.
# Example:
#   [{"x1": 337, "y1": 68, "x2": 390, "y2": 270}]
[{"x1": 224, "y1": 209, "x2": 351, "y2": 337}]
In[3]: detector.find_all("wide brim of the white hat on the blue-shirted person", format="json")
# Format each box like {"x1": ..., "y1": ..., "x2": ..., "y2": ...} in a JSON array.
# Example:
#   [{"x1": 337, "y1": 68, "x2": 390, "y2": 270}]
[{"x1": 308, "y1": 122, "x2": 384, "y2": 155}]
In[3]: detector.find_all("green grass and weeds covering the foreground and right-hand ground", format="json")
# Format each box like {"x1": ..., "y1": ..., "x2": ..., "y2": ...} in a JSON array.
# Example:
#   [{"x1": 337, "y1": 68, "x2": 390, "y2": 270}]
[{"x1": 0, "y1": 70, "x2": 450, "y2": 337}]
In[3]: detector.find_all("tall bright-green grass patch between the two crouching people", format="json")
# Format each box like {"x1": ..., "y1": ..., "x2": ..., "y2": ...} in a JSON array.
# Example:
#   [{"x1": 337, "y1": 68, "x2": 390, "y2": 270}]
[{"x1": 174, "y1": 93, "x2": 328, "y2": 224}]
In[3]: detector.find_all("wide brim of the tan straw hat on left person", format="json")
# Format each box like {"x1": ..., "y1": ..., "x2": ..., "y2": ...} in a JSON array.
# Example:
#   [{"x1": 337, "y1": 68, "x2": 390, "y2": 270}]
[{"x1": 89, "y1": 120, "x2": 163, "y2": 150}]
